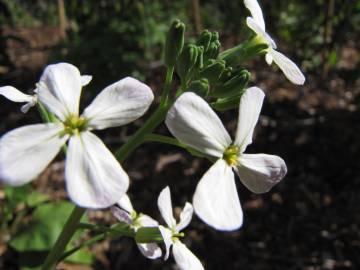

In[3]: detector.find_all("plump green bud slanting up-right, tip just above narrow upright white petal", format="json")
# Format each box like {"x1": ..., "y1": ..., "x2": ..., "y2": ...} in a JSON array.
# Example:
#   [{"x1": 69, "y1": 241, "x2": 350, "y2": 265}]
[{"x1": 211, "y1": 69, "x2": 251, "y2": 98}]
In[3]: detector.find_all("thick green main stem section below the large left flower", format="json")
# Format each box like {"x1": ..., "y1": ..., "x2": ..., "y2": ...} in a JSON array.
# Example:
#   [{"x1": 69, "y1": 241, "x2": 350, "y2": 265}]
[{"x1": 42, "y1": 206, "x2": 86, "y2": 270}]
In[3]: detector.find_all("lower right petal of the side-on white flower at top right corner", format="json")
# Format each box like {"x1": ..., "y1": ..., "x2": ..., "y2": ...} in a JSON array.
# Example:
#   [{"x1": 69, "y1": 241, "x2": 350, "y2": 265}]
[{"x1": 268, "y1": 49, "x2": 305, "y2": 85}]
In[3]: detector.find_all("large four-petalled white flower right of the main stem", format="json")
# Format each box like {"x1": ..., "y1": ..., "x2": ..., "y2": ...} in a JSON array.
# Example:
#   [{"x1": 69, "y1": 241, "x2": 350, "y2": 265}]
[{"x1": 166, "y1": 90, "x2": 287, "y2": 230}]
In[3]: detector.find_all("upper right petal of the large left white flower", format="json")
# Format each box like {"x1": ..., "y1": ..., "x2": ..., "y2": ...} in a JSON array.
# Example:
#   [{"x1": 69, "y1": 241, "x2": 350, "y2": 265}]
[{"x1": 84, "y1": 77, "x2": 154, "y2": 129}]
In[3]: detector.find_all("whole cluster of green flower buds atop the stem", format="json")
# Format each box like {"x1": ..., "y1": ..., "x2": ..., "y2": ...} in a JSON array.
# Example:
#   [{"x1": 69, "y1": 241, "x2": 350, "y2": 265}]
[{"x1": 165, "y1": 20, "x2": 256, "y2": 110}]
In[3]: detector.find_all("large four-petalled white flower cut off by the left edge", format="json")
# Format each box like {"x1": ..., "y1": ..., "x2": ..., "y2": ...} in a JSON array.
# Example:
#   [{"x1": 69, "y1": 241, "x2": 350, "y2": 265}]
[{"x1": 0, "y1": 63, "x2": 154, "y2": 208}]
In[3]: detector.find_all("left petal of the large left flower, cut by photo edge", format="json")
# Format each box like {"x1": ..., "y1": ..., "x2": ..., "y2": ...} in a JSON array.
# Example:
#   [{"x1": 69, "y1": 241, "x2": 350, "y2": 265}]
[{"x1": 0, "y1": 124, "x2": 67, "y2": 186}]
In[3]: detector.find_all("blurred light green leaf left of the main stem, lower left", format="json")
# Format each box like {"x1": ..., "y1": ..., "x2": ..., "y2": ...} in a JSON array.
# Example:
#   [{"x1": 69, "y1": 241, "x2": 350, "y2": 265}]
[{"x1": 10, "y1": 202, "x2": 86, "y2": 252}]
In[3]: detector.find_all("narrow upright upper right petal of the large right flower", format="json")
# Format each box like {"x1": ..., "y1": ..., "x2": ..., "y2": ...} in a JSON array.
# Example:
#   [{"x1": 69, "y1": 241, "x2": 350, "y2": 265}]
[{"x1": 234, "y1": 87, "x2": 265, "y2": 153}]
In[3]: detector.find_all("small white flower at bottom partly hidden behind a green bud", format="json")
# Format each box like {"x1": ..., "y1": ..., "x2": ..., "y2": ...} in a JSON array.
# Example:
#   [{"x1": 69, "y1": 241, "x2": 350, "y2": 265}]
[{"x1": 111, "y1": 194, "x2": 162, "y2": 259}]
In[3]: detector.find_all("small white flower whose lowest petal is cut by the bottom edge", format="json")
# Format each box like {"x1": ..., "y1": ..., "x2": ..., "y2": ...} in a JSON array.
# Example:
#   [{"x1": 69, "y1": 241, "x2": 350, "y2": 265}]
[{"x1": 158, "y1": 187, "x2": 204, "y2": 270}]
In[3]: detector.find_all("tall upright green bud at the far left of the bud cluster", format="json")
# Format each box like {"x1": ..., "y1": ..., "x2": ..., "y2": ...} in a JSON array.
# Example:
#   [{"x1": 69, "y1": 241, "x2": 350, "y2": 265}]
[{"x1": 165, "y1": 20, "x2": 185, "y2": 67}]
